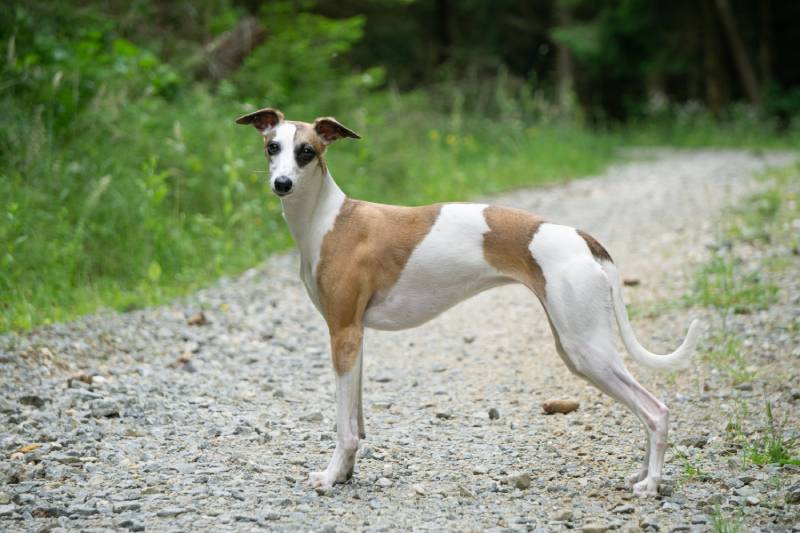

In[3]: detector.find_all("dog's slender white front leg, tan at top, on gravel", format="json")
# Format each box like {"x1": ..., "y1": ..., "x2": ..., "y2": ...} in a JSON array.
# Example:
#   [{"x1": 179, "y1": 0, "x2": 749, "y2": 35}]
[{"x1": 309, "y1": 326, "x2": 364, "y2": 491}]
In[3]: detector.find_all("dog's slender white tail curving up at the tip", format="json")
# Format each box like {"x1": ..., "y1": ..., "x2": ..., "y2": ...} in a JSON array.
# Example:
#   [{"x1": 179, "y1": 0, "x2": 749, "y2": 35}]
[{"x1": 602, "y1": 261, "x2": 700, "y2": 370}]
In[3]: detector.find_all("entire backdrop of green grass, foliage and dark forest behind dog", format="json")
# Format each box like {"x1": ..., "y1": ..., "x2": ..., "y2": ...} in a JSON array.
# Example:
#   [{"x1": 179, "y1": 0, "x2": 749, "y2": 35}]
[{"x1": 0, "y1": 0, "x2": 800, "y2": 331}]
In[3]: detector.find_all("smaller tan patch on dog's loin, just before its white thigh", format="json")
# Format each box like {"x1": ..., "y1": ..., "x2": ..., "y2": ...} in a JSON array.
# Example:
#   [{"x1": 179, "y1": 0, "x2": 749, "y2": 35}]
[{"x1": 483, "y1": 206, "x2": 545, "y2": 300}]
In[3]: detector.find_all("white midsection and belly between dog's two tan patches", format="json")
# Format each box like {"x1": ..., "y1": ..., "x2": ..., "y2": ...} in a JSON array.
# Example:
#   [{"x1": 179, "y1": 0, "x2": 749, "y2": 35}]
[{"x1": 364, "y1": 204, "x2": 513, "y2": 330}]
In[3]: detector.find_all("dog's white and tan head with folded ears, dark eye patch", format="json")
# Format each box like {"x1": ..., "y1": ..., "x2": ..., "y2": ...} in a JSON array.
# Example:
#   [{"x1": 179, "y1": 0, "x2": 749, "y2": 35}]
[{"x1": 236, "y1": 108, "x2": 361, "y2": 197}]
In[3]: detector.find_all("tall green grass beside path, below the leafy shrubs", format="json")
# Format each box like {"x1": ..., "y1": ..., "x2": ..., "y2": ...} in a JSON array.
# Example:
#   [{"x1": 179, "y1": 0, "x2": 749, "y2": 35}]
[{"x1": 0, "y1": 89, "x2": 618, "y2": 331}]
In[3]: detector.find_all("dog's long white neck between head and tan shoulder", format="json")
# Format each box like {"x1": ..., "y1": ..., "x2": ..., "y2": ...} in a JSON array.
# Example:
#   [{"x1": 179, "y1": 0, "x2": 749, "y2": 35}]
[{"x1": 281, "y1": 165, "x2": 345, "y2": 261}]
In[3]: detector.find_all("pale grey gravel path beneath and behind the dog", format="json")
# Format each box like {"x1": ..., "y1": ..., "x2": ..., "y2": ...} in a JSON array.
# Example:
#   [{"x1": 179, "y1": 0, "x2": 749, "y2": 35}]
[{"x1": 0, "y1": 151, "x2": 800, "y2": 532}]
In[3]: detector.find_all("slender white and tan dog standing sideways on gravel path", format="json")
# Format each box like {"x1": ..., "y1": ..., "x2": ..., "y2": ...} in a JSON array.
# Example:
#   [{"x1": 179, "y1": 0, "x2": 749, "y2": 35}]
[{"x1": 236, "y1": 109, "x2": 699, "y2": 496}]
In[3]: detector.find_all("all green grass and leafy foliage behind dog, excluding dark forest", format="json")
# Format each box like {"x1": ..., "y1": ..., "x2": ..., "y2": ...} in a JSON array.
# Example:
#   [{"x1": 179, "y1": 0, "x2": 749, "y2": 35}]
[{"x1": 0, "y1": 0, "x2": 792, "y2": 331}]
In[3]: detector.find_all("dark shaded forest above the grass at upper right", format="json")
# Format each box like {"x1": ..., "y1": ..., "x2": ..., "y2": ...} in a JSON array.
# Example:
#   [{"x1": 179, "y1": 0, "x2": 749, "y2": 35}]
[{"x1": 324, "y1": 0, "x2": 800, "y2": 121}]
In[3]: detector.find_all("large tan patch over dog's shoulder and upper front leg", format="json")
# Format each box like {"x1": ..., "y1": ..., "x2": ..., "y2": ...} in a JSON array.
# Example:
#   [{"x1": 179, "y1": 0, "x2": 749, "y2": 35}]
[{"x1": 317, "y1": 198, "x2": 441, "y2": 375}]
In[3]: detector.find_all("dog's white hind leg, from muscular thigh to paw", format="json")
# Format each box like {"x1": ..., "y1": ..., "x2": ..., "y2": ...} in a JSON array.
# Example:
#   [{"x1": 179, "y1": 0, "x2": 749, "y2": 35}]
[{"x1": 545, "y1": 258, "x2": 668, "y2": 496}]
